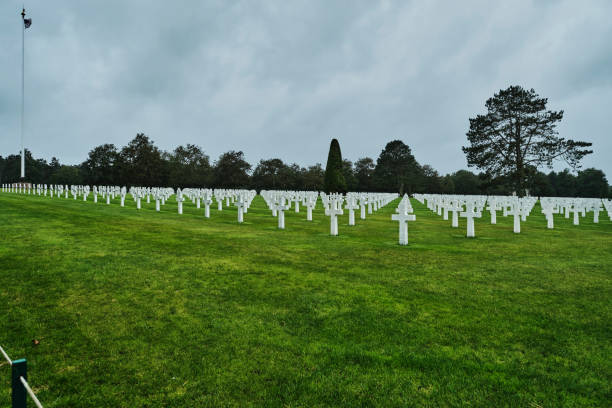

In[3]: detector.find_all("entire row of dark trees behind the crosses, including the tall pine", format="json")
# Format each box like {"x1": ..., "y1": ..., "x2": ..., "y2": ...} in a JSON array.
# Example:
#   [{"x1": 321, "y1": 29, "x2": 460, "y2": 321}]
[{"x1": 0, "y1": 85, "x2": 611, "y2": 197}]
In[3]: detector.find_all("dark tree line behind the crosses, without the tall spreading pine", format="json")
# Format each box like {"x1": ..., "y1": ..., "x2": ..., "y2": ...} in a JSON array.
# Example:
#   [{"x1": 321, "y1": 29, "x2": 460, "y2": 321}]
[{"x1": 0, "y1": 133, "x2": 612, "y2": 198}]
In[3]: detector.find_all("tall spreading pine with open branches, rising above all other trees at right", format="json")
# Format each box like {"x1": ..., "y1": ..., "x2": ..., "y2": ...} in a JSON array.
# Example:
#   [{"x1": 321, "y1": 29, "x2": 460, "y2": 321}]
[{"x1": 463, "y1": 86, "x2": 592, "y2": 196}]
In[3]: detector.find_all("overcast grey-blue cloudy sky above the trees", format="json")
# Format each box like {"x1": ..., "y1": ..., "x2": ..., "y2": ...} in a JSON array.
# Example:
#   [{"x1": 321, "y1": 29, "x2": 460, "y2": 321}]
[{"x1": 0, "y1": 0, "x2": 612, "y2": 178}]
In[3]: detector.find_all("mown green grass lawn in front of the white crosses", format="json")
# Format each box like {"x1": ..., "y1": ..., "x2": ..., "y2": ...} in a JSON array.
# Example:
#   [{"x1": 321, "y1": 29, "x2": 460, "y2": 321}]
[{"x1": 0, "y1": 193, "x2": 612, "y2": 408}]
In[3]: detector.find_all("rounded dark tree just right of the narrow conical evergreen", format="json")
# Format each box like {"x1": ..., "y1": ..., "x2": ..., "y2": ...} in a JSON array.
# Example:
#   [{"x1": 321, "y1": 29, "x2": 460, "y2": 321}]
[{"x1": 374, "y1": 140, "x2": 421, "y2": 195}]
